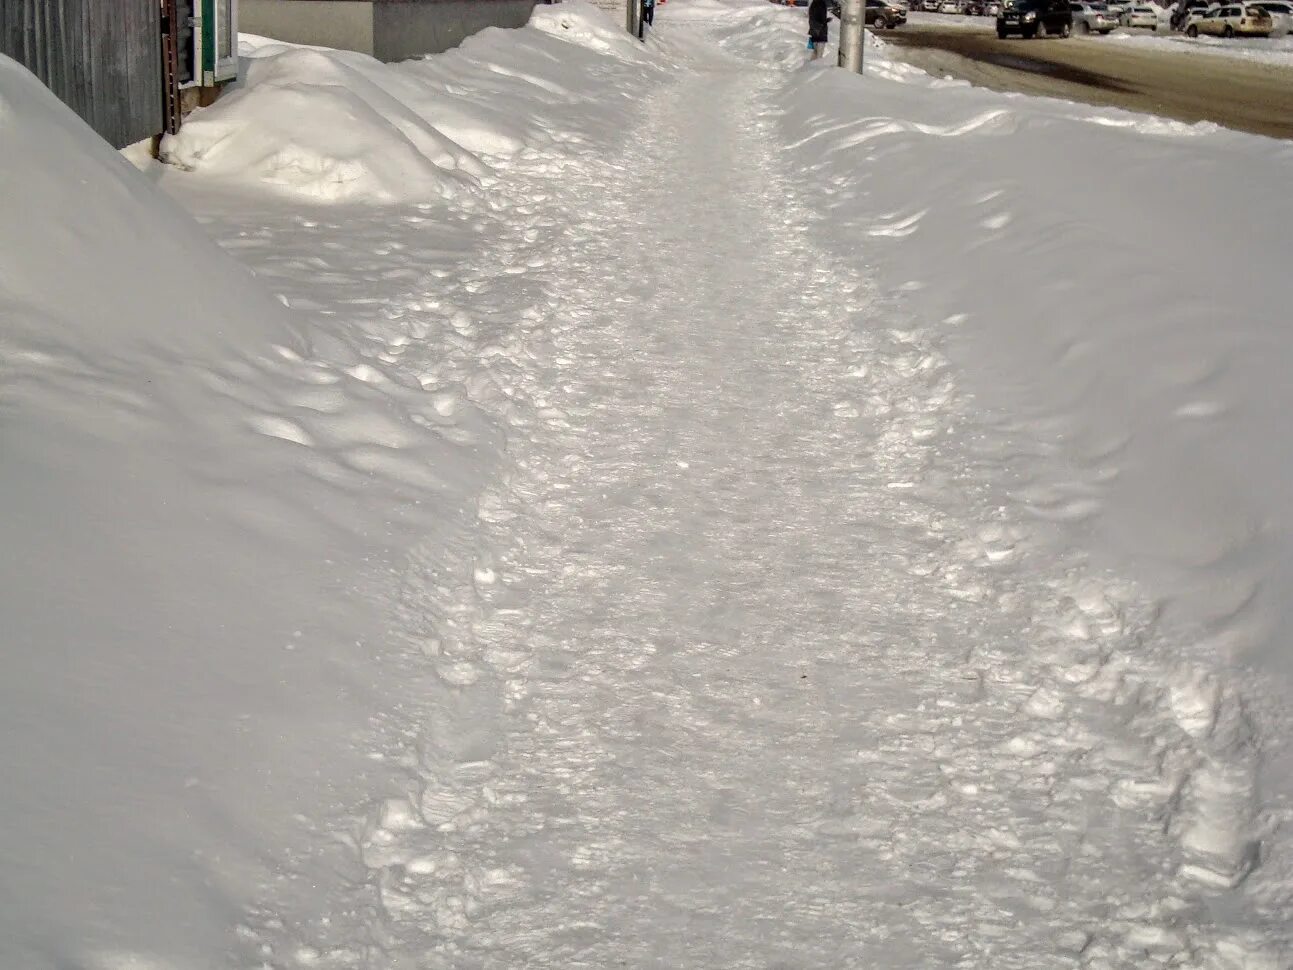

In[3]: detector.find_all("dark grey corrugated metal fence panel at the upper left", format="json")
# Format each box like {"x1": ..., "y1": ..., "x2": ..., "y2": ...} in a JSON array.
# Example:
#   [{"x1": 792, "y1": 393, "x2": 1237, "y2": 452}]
[{"x1": 0, "y1": 0, "x2": 163, "y2": 147}]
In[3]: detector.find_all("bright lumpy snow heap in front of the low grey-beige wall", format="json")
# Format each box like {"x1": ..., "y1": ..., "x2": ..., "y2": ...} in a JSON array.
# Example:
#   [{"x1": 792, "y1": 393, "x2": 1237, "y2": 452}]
[{"x1": 163, "y1": 3, "x2": 648, "y2": 203}]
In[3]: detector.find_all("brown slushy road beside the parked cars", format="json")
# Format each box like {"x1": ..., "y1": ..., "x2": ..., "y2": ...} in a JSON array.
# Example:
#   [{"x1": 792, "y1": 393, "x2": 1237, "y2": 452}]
[{"x1": 882, "y1": 22, "x2": 1293, "y2": 138}]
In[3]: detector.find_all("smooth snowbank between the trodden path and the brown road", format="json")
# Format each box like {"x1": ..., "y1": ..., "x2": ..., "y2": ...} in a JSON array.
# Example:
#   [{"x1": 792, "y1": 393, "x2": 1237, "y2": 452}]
[{"x1": 724, "y1": 0, "x2": 1293, "y2": 673}]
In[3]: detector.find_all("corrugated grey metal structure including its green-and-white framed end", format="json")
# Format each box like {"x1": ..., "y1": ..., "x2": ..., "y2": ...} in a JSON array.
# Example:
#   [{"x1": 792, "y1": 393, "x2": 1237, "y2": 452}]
[{"x1": 0, "y1": 0, "x2": 238, "y2": 147}]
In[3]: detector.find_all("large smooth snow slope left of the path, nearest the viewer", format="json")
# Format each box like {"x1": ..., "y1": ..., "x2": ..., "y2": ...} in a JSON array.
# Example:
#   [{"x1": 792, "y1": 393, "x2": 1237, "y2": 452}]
[{"x1": 0, "y1": 57, "x2": 490, "y2": 970}]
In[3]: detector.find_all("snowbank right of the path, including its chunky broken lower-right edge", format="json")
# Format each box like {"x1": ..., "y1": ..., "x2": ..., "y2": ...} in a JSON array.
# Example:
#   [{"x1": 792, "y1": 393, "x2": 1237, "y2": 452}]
[{"x1": 720, "y1": 0, "x2": 1293, "y2": 941}]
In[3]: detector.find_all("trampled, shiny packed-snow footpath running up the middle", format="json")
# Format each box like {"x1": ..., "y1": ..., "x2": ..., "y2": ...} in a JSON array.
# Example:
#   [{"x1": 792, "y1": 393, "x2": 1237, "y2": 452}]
[{"x1": 230, "y1": 20, "x2": 1275, "y2": 970}]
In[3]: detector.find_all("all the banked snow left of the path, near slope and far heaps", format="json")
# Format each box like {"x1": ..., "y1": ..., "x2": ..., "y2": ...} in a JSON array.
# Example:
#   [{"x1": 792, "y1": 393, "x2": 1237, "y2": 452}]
[{"x1": 0, "y1": 3, "x2": 662, "y2": 970}]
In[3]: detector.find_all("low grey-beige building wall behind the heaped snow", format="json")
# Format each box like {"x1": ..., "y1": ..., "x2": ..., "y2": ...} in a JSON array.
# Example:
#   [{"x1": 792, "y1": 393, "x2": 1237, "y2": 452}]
[{"x1": 238, "y1": 0, "x2": 534, "y2": 61}]
